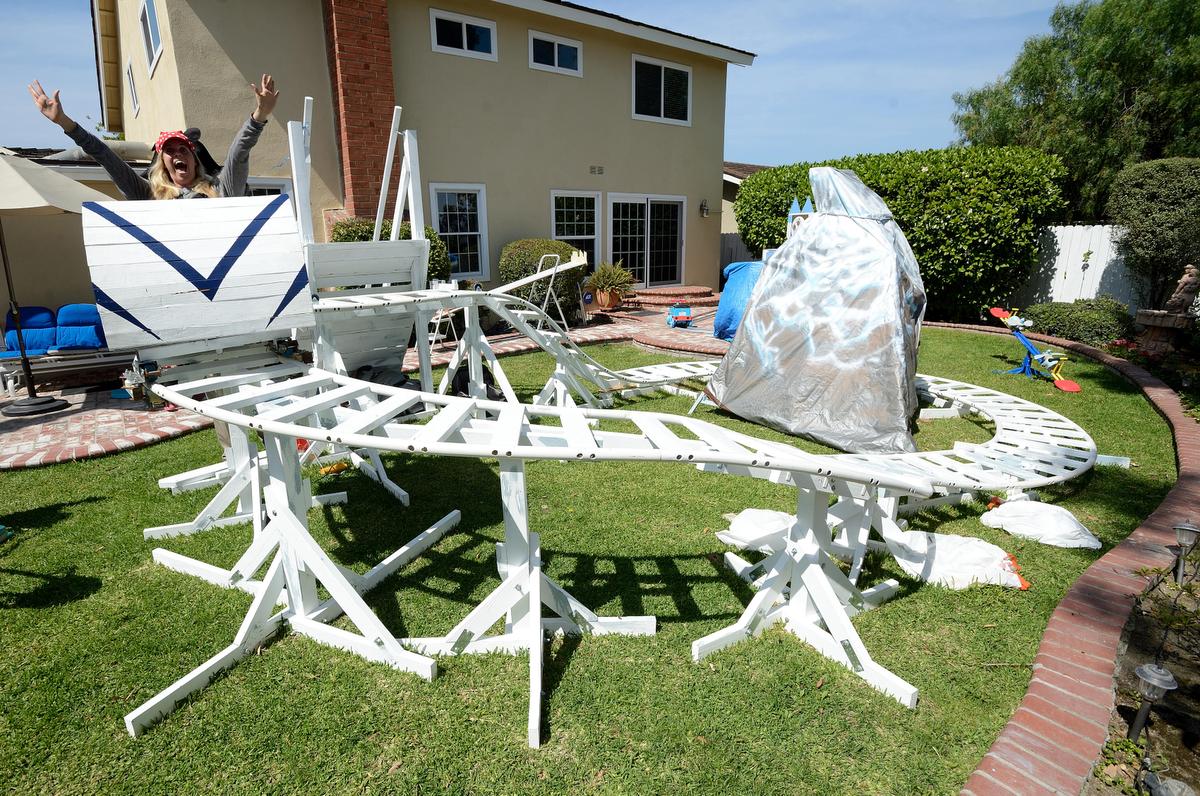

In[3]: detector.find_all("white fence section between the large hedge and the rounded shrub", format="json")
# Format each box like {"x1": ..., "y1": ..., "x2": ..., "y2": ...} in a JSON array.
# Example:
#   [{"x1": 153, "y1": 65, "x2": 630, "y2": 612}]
[{"x1": 1013, "y1": 225, "x2": 1139, "y2": 312}]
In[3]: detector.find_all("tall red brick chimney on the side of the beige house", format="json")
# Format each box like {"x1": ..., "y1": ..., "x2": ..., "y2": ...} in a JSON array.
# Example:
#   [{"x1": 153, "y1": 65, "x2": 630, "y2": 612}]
[{"x1": 324, "y1": 0, "x2": 396, "y2": 223}]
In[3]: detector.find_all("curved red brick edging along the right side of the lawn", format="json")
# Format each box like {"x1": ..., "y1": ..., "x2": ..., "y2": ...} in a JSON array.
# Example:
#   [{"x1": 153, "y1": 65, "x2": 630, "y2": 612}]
[{"x1": 926, "y1": 323, "x2": 1200, "y2": 796}]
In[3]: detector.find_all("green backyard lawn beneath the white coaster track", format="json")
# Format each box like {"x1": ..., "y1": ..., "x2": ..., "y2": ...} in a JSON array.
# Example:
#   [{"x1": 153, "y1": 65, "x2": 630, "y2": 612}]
[{"x1": 0, "y1": 329, "x2": 1176, "y2": 794}]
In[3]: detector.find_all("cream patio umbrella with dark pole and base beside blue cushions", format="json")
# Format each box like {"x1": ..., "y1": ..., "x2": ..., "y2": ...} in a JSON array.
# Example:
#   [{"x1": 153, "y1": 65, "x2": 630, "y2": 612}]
[{"x1": 0, "y1": 146, "x2": 112, "y2": 417}]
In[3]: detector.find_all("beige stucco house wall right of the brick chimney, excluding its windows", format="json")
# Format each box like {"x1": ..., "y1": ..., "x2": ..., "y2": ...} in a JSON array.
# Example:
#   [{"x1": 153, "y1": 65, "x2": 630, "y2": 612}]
[{"x1": 390, "y1": 0, "x2": 726, "y2": 287}]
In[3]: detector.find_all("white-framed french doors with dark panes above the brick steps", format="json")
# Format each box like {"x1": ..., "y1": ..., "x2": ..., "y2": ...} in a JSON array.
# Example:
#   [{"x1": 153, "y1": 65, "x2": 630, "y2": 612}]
[{"x1": 608, "y1": 193, "x2": 684, "y2": 287}]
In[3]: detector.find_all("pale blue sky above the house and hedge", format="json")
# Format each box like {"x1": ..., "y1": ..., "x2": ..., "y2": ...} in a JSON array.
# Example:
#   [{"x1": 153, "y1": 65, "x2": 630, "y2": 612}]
[{"x1": 0, "y1": 0, "x2": 1054, "y2": 164}]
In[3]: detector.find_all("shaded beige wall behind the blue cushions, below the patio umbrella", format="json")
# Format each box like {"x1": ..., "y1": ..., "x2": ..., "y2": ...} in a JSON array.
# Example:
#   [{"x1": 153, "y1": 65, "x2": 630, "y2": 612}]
[{"x1": 0, "y1": 180, "x2": 124, "y2": 310}]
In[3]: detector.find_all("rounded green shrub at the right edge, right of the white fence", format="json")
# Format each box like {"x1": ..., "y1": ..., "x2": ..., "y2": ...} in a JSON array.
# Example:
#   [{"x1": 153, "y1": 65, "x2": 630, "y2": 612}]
[{"x1": 1108, "y1": 157, "x2": 1200, "y2": 307}]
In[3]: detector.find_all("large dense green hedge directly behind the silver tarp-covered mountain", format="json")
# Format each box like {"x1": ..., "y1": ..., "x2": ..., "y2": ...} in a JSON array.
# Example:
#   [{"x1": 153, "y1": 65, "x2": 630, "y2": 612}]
[{"x1": 733, "y1": 146, "x2": 1066, "y2": 321}]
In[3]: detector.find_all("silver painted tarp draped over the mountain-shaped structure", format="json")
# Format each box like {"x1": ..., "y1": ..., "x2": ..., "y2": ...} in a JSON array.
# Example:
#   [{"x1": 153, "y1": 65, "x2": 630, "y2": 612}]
[{"x1": 708, "y1": 167, "x2": 925, "y2": 453}]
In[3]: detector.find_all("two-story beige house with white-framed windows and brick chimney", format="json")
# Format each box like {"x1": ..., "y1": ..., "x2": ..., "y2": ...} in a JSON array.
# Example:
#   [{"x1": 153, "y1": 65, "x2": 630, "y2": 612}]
[{"x1": 92, "y1": 0, "x2": 754, "y2": 287}]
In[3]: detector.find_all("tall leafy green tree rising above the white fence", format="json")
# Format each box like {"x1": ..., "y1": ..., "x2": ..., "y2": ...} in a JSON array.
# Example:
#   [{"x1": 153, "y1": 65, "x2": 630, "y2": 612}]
[{"x1": 953, "y1": 0, "x2": 1200, "y2": 220}]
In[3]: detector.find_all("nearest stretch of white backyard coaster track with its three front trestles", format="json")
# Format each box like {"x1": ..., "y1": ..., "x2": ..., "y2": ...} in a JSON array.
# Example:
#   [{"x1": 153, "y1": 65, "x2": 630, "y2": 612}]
[{"x1": 144, "y1": 369, "x2": 930, "y2": 746}]
